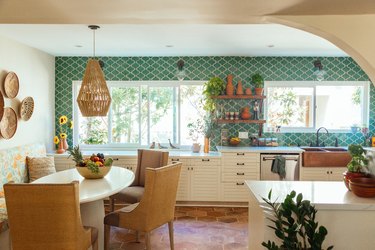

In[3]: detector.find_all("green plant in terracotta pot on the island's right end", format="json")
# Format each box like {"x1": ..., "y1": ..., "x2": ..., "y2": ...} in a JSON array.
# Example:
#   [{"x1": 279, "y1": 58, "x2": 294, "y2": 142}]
[{"x1": 343, "y1": 144, "x2": 369, "y2": 190}]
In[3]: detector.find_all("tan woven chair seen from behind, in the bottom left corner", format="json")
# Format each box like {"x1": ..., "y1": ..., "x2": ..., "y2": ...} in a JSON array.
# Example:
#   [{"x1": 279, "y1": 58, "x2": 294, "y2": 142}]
[{"x1": 4, "y1": 181, "x2": 98, "y2": 250}]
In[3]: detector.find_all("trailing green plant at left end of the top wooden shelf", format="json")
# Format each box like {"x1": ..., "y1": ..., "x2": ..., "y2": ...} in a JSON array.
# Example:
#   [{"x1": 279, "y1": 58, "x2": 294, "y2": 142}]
[{"x1": 203, "y1": 76, "x2": 225, "y2": 112}]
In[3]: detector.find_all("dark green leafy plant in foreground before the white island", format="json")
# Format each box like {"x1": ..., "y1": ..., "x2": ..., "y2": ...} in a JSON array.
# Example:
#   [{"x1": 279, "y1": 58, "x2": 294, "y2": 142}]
[{"x1": 262, "y1": 189, "x2": 333, "y2": 250}]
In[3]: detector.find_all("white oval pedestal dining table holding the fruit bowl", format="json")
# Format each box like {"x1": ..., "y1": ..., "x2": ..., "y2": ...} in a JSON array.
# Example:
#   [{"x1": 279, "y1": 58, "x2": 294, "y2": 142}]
[{"x1": 33, "y1": 166, "x2": 134, "y2": 249}]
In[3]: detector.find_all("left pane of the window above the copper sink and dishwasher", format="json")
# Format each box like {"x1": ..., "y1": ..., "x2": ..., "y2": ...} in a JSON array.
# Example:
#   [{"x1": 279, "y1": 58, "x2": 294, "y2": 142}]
[{"x1": 267, "y1": 87, "x2": 314, "y2": 128}]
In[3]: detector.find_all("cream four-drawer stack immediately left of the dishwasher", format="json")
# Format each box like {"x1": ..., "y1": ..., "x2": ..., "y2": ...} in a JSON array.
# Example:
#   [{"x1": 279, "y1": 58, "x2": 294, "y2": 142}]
[{"x1": 220, "y1": 152, "x2": 260, "y2": 202}]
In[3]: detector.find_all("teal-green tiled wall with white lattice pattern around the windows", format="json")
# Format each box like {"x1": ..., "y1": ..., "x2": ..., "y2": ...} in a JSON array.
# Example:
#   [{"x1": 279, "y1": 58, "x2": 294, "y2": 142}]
[{"x1": 55, "y1": 57, "x2": 375, "y2": 149}]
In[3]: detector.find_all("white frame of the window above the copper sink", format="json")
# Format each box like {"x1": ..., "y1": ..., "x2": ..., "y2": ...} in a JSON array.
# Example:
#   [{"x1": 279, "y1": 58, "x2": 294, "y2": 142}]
[{"x1": 263, "y1": 81, "x2": 371, "y2": 133}]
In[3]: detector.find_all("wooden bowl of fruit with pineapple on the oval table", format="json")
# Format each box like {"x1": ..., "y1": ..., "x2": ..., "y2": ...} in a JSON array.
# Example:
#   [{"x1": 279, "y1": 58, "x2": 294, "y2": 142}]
[{"x1": 68, "y1": 146, "x2": 113, "y2": 179}]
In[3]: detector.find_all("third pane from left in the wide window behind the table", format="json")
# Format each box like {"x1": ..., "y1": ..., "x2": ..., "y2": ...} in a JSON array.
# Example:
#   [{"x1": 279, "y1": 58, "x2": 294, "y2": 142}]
[{"x1": 149, "y1": 87, "x2": 177, "y2": 144}]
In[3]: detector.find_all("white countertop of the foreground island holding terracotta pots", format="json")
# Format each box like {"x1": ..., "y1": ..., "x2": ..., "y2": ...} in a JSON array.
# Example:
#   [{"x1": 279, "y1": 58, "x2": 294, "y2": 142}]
[{"x1": 246, "y1": 181, "x2": 375, "y2": 210}]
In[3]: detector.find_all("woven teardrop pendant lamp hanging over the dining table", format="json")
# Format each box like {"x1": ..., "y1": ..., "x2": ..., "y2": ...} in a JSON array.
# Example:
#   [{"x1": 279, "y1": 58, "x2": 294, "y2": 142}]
[{"x1": 77, "y1": 25, "x2": 111, "y2": 117}]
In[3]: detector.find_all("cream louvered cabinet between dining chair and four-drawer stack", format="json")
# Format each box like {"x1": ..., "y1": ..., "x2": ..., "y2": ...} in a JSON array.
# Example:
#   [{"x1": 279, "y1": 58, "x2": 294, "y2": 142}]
[{"x1": 170, "y1": 157, "x2": 220, "y2": 201}]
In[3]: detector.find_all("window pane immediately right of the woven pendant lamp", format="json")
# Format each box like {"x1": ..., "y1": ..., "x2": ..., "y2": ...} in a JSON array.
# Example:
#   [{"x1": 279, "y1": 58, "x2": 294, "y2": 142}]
[{"x1": 111, "y1": 87, "x2": 140, "y2": 143}]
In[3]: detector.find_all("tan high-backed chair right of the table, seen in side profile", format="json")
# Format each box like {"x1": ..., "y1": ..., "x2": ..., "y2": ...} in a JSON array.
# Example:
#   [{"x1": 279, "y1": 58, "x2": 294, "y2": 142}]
[{"x1": 104, "y1": 162, "x2": 182, "y2": 250}]
